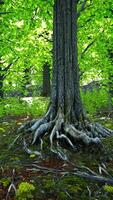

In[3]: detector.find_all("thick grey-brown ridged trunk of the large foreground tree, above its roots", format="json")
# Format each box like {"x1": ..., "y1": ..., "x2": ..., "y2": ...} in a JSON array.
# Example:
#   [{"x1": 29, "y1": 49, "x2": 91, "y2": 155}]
[{"x1": 52, "y1": 0, "x2": 83, "y2": 122}]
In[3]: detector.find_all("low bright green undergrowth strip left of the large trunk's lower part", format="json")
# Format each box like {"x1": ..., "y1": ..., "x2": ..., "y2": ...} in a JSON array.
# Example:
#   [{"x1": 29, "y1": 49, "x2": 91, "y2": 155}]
[{"x1": 0, "y1": 97, "x2": 49, "y2": 117}]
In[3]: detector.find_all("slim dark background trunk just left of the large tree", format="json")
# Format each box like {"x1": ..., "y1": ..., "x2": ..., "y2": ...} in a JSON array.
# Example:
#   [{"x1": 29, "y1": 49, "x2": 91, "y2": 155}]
[{"x1": 42, "y1": 63, "x2": 50, "y2": 97}]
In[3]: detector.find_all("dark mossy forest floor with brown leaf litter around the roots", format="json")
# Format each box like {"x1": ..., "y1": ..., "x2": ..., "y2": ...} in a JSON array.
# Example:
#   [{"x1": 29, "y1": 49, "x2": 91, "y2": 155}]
[{"x1": 0, "y1": 113, "x2": 113, "y2": 200}]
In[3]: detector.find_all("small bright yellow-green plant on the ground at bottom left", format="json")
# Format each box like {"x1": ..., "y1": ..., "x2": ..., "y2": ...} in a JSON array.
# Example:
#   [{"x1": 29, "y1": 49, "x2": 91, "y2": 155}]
[{"x1": 16, "y1": 182, "x2": 35, "y2": 200}]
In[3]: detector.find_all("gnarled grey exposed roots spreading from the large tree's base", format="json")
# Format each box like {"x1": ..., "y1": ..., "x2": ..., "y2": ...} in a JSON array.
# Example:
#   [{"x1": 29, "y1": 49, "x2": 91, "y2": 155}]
[{"x1": 19, "y1": 107, "x2": 113, "y2": 160}]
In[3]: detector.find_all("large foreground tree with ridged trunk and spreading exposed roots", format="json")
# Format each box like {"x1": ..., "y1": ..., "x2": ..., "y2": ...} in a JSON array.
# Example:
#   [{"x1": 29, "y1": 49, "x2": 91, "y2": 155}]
[{"x1": 18, "y1": 0, "x2": 113, "y2": 154}]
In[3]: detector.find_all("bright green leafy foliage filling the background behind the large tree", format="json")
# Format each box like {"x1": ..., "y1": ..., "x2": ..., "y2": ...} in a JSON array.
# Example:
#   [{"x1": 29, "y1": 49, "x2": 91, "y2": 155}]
[{"x1": 0, "y1": 0, "x2": 113, "y2": 119}]
